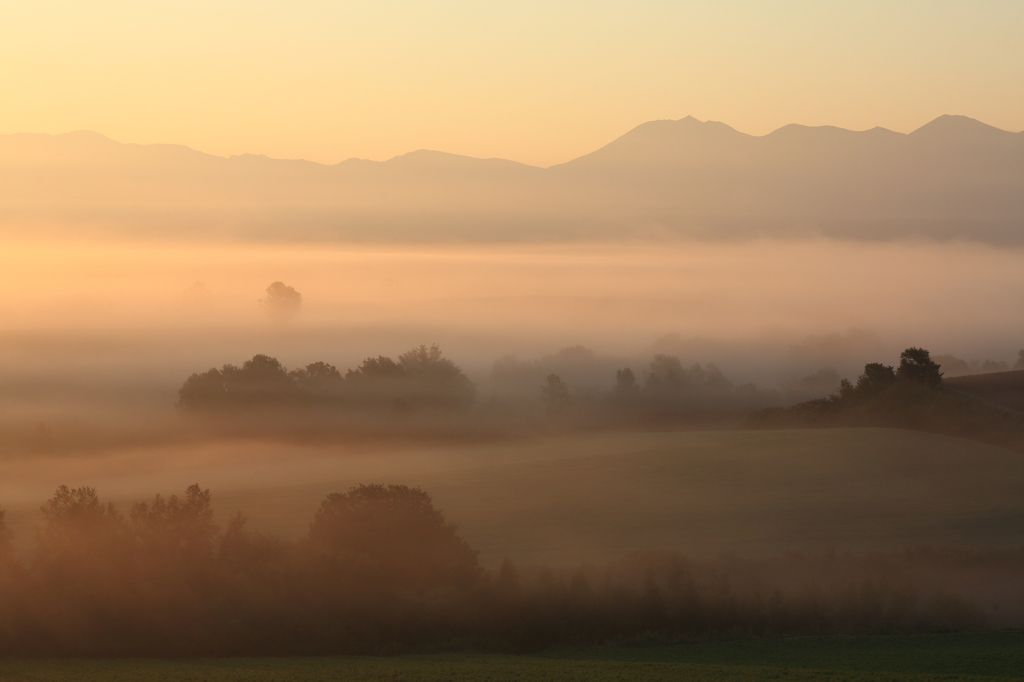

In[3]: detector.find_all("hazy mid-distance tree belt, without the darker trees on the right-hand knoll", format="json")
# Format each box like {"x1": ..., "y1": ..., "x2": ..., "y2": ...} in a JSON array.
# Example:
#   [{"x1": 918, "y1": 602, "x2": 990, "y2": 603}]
[{"x1": 177, "y1": 345, "x2": 778, "y2": 436}]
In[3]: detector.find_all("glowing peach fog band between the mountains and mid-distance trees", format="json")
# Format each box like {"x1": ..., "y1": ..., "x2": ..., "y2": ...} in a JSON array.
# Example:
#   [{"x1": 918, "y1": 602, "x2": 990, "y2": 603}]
[{"x1": 0, "y1": 236, "x2": 1024, "y2": 393}]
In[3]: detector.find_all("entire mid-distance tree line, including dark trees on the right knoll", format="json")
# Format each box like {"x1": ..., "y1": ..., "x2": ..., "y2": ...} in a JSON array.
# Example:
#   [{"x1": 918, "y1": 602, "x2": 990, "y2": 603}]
[{"x1": 178, "y1": 345, "x2": 1024, "y2": 449}]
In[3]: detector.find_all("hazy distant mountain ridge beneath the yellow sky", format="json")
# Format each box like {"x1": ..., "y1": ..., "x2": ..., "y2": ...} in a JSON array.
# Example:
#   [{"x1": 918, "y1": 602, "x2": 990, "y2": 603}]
[{"x1": 0, "y1": 116, "x2": 1024, "y2": 243}]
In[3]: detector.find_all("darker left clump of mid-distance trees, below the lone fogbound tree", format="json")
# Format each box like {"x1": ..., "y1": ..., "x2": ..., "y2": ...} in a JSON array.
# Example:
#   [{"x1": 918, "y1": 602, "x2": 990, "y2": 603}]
[{"x1": 178, "y1": 345, "x2": 475, "y2": 413}]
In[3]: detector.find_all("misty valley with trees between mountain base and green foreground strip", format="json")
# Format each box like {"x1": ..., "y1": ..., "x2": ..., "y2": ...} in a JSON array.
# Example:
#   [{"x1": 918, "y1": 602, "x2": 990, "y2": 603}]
[{"x1": 0, "y1": 243, "x2": 1024, "y2": 656}]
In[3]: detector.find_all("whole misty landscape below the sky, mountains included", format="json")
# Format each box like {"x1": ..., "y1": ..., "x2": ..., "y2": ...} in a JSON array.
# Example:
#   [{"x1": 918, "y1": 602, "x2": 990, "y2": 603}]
[{"x1": 0, "y1": 107, "x2": 1024, "y2": 680}]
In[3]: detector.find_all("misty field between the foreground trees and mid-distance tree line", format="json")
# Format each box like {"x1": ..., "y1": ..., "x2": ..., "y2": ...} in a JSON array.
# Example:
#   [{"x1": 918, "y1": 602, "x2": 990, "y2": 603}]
[{"x1": 0, "y1": 429, "x2": 1024, "y2": 565}]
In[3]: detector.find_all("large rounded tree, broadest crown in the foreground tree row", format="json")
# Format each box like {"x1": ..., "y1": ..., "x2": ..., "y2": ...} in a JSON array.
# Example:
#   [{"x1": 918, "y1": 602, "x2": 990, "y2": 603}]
[{"x1": 308, "y1": 485, "x2": 479, "y2": 592}]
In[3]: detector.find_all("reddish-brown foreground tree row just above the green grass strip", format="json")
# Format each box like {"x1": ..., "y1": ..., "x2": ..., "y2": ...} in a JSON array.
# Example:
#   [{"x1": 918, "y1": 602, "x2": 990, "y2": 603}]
[{"x1": 0, "y1": 485, "x2": 1024, "y2": 656}]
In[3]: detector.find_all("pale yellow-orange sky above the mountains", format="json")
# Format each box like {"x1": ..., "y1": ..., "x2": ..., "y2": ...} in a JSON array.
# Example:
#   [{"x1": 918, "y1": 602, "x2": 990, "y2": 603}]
[{"x1": 0, "y1": 0, "x2": 1024, "y2": 166}]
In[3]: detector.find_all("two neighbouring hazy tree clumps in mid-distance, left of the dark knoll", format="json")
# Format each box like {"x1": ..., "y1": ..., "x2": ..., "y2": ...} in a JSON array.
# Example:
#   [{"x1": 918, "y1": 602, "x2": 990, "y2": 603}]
[{"x1": 177, "y1": 345, "x2": 778, "y2": 428}]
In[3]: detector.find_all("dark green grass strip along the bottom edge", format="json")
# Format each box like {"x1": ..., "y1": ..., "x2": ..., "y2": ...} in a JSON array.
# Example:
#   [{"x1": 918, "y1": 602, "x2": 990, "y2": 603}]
[{"x1": 0, "y1": 632, "x2": 1024, "y2": 682}]
